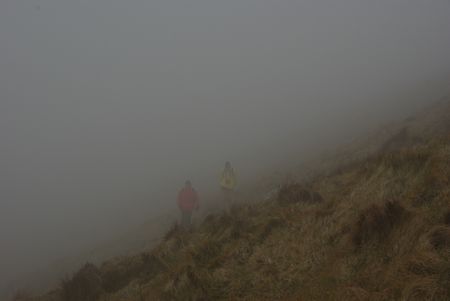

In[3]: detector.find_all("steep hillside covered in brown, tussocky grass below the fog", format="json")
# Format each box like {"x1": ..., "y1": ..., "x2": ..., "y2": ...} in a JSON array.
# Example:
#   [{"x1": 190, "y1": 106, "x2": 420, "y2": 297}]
[{"x1": 22, "y1": 99, "x2": 450, "y2": 301}]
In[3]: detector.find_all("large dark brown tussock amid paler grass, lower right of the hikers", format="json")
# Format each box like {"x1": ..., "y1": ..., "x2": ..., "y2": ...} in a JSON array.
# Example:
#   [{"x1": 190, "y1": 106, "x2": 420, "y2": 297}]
[{"x1": 352, "y1": 201, "x2": 406, "y2": 247}]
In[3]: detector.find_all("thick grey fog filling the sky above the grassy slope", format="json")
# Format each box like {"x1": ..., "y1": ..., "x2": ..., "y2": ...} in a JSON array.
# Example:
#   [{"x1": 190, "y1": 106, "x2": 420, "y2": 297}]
[{"x1": 0, "y1": 0, "x2": 450, "y2": 288}]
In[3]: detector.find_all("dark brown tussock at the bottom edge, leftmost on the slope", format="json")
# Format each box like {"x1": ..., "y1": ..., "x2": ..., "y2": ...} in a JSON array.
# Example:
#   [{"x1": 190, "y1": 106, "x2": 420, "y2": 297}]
[{"x1": 61, "y1": 263, "x2": 103, "y2": 301}]
